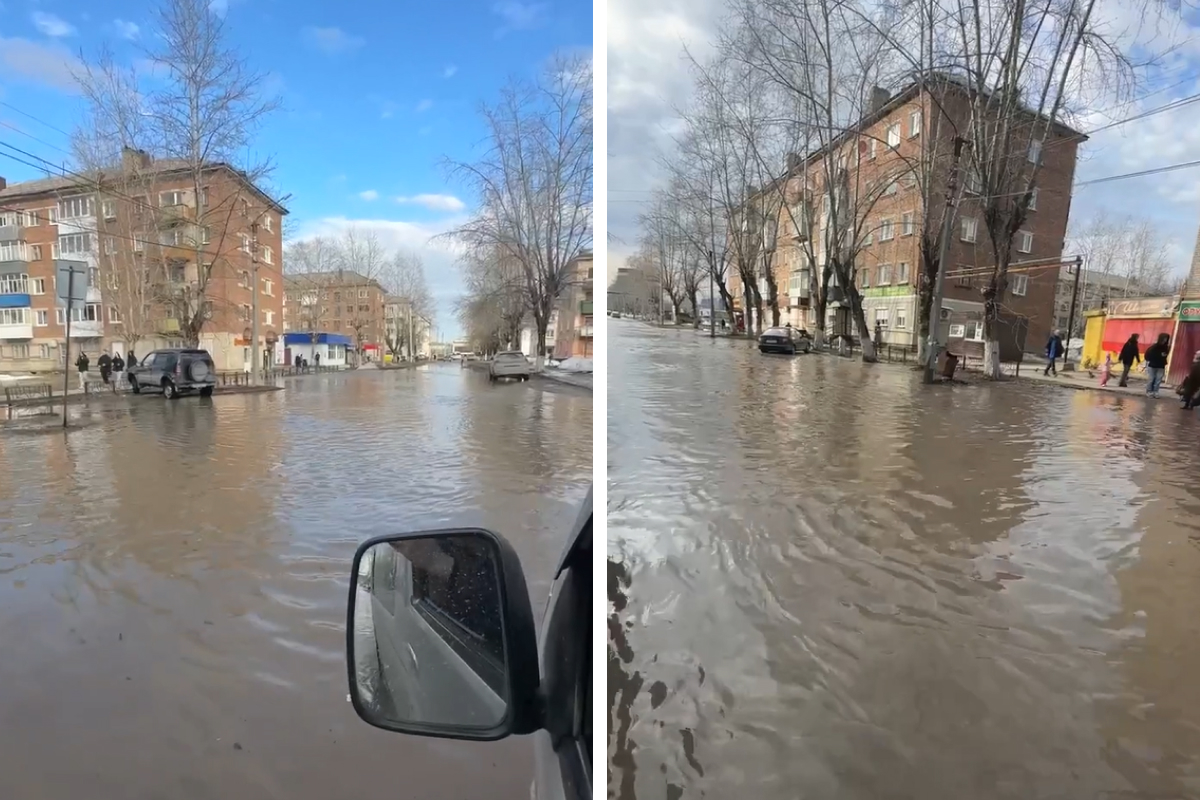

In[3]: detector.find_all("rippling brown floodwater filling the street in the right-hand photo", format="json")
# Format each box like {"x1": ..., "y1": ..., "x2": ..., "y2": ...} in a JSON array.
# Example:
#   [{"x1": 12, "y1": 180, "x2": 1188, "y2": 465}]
[{"x1": 608, "y1": 321, "x2": 1200, "y2": 800}]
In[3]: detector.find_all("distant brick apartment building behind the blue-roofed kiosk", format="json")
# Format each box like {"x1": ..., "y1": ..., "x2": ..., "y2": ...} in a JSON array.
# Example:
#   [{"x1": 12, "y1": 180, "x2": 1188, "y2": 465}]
[{"x1": 283, "y1": 270, "x2": 388, "y2": 359}]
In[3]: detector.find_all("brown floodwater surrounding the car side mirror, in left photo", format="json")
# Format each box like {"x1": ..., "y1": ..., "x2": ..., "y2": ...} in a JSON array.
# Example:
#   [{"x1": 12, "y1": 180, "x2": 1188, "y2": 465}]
[{"x1": 0, "y1": 366, "x2": 592, "y2": 800}]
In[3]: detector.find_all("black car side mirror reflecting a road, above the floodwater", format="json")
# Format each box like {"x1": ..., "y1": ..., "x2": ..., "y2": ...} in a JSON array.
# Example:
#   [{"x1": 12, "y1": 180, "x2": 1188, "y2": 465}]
[{"x1": 346, "y1": 529, "x2": 542, "y2": 741}]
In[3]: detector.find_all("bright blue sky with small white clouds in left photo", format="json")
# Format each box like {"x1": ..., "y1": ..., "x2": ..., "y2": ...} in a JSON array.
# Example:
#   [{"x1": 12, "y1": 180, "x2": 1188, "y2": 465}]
[{"x1": 0, "y1": 0, "x2": 592, "y2": 336}]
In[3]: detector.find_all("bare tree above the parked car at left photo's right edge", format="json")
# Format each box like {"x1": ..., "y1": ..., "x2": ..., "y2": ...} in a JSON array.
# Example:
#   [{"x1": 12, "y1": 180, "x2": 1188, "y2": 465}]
[{"x1": 449, "y1": 56, "x2": 593, "y2": 366}]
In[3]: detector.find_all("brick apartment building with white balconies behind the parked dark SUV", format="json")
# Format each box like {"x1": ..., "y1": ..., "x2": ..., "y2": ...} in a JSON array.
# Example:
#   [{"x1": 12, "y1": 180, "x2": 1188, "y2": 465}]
[{"x1": 0, "y1": 151, "x2": 287, "y2": 372}]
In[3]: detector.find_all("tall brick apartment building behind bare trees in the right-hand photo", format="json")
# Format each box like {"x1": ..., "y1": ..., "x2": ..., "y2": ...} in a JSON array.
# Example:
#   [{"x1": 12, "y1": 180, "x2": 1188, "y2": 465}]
[{"x1": 730, "y1": 79, "x2": 1086, "y2": 354}]
